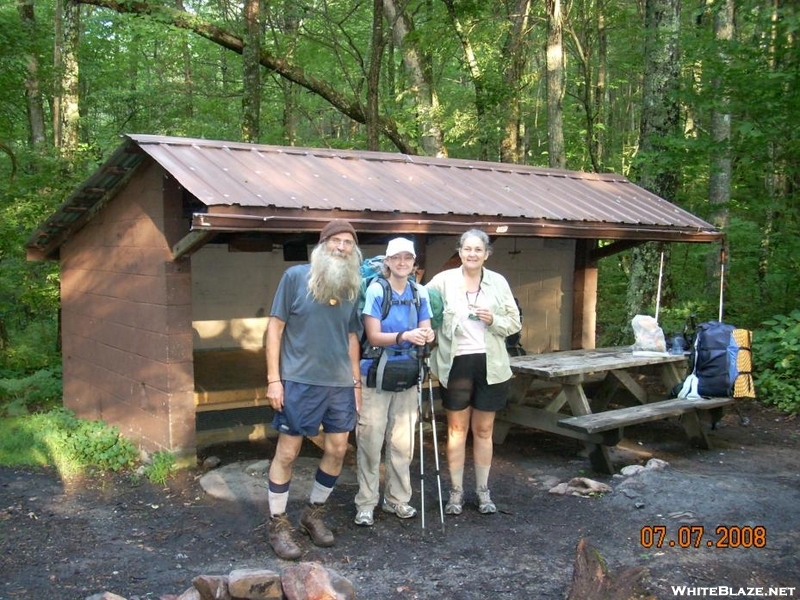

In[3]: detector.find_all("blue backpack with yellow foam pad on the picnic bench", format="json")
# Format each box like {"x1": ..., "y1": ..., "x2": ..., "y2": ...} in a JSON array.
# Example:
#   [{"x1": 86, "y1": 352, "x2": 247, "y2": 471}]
[{"x1": 678, "y1": 321, "x2": 755, "y2": 398}]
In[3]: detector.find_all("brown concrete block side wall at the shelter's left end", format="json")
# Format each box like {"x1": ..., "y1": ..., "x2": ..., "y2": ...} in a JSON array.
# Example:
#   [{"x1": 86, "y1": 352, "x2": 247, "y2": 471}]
[{"x1": 61, "y1": 163, "x2": 195, "y2": 452}]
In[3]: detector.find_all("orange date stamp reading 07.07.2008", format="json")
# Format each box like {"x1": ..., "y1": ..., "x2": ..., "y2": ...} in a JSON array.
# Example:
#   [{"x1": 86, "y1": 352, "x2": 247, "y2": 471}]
[{"x1": 639, "y1": 525, "x2": 767, "y2": 548}]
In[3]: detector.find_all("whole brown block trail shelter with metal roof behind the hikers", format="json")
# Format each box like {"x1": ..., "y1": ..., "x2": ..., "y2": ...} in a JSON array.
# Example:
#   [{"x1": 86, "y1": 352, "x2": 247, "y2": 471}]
[{"x1": 26, "y1": 135, "x2": 722, "y2": 454}]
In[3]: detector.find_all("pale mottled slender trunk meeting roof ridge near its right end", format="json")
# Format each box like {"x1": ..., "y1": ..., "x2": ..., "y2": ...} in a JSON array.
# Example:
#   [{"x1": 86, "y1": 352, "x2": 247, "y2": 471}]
[{"x1": 546, "y1": 0, "x2": 567, "y2": 169}]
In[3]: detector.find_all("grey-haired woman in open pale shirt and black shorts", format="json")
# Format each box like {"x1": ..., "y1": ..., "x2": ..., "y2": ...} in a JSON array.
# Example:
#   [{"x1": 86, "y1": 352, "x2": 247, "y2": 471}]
[{"x1": 426, "y1": 229, "x2": 521, "y2": 515}]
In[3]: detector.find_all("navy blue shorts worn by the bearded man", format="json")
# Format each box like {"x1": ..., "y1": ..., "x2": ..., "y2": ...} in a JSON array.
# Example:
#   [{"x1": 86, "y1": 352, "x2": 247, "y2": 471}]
[{"x1": 272, "y1": 381, "x2": 358, "y2": 436}]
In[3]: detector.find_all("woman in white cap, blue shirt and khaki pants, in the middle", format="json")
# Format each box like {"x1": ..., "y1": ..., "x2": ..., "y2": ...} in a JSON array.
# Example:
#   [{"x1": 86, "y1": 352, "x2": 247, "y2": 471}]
[{"x1": 355, "y1": 237, "x2": 434, "y2": 527}]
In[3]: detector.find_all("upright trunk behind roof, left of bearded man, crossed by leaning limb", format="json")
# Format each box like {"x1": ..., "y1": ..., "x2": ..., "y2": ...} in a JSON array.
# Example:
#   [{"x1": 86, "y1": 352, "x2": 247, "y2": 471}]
[{"x1": 242, "y1": 0, "x2": 261, "y2": 143}]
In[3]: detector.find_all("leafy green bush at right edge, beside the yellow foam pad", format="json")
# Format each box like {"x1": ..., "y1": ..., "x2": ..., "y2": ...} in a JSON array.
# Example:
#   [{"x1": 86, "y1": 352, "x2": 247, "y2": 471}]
[{"x1": 753, "y1": 310, "x2": 800, "y2": 414}]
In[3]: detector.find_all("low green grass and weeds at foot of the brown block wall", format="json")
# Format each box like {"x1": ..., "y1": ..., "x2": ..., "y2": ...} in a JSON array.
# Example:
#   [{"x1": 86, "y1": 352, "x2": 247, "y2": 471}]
[{"x1": 0, "y1": 408, "x2": 137, "y2": 476}]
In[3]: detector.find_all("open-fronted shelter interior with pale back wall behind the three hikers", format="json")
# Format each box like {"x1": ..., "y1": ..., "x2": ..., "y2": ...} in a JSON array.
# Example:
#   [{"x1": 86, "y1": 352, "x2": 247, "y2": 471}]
[{"x1": 191, "y1": 233, "x2": 576, "y2": 446}]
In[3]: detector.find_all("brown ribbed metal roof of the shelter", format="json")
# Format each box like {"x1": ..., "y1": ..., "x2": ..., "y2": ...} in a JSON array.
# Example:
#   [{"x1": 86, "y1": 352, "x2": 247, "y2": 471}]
[{"x1": 27, "y1": 135, "x2": 722, "y2": 258}]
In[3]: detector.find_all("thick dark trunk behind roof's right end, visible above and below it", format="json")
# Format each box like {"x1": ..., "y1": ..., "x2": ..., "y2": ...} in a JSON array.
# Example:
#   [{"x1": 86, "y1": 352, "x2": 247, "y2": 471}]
[{"x1": 627, "y1": 0, "x2": 680, "y2": 318}]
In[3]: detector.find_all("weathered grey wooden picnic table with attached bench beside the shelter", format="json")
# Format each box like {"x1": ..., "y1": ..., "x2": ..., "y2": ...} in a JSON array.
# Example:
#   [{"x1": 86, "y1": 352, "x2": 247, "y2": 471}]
[{"x1": 494, "y1": 347, "x2": 734, "y2": 473}]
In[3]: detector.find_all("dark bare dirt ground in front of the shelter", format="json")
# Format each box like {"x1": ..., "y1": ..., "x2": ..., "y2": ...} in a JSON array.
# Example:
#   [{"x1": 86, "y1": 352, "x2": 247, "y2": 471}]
[{"x1": 0, "y1": 403, "x2": 800, "y2": 600}]
